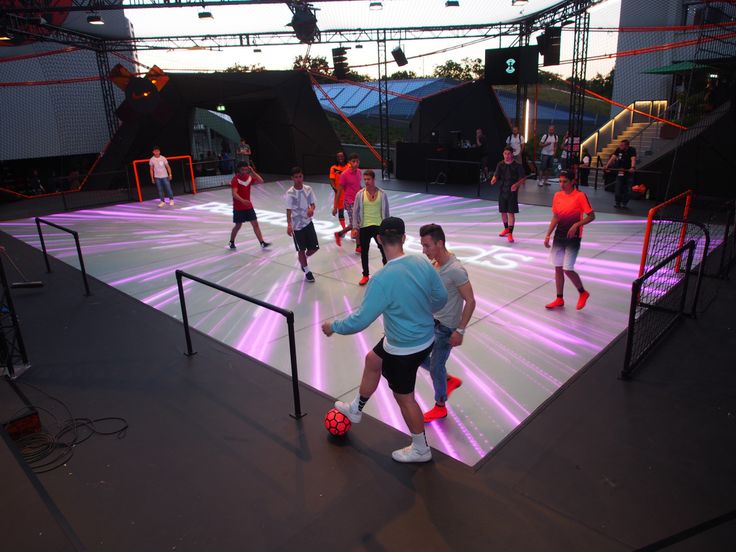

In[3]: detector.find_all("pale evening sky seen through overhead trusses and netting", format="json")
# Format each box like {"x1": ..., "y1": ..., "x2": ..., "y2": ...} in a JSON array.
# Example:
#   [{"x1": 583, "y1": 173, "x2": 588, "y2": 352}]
[{"x1": 125, "y1": 0, "x2": 621, "y2": 78}]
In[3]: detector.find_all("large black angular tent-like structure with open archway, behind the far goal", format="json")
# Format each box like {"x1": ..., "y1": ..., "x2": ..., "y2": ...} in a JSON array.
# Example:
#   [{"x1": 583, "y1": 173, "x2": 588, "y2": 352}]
[{"x1": 90, "y1": 71, "x2": 340, "y2": 184}]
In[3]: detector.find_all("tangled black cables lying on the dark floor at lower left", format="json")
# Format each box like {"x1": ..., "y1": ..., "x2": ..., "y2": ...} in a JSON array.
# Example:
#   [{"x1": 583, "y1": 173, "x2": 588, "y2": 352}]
[{"x1": 16, "y1": 381, "x2": 129, "y2": 473}]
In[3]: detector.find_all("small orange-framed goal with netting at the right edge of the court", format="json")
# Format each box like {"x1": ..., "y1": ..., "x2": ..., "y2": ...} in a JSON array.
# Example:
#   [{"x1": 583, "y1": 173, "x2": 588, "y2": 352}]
[{"x1": 639, "y1": 190, "x2": 693, "y2": 278}]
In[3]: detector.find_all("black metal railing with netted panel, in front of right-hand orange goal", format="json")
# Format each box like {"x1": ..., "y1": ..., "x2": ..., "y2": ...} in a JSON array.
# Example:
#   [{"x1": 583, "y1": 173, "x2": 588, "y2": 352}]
[{"x1": 621, "y1": 240, "x2": 703, "y2": 379}]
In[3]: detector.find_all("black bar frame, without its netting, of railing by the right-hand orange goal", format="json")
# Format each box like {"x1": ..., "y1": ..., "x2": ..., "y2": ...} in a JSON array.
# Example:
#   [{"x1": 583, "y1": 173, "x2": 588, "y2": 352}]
[{"x1": 620, "y1": 240, "x2": 704, "y2": 380}]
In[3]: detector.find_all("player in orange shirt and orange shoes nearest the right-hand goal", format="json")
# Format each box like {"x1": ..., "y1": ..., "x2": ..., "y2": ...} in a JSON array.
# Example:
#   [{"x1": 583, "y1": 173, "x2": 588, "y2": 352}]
[{"x1": 544, "y1": 171, "x2": 595, "y2": 310}]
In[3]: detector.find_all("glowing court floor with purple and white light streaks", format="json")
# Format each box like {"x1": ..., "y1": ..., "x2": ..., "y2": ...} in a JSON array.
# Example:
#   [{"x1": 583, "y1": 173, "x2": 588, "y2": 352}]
[{"x1": 0, "y1": 181, "x2": 644, "y2": 465}]
